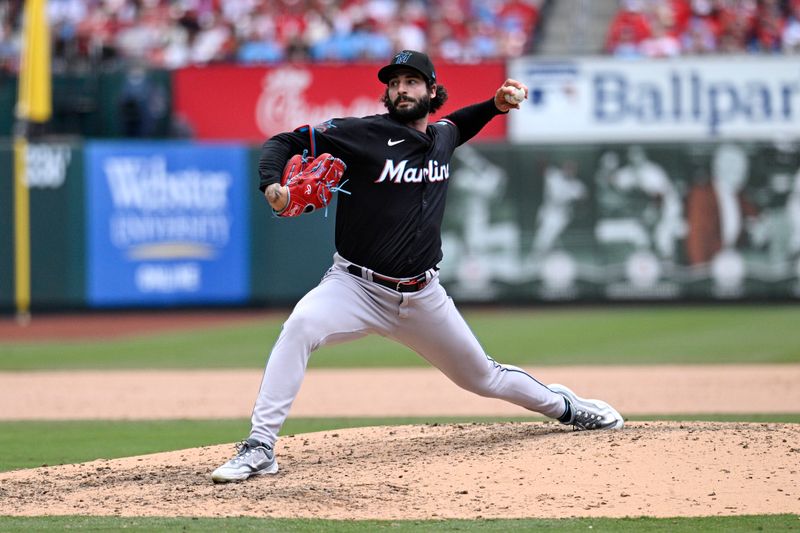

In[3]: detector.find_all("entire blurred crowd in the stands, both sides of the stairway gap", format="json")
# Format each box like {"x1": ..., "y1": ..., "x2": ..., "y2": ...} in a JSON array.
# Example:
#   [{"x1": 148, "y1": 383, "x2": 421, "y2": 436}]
[{"x1": 0, "y1": 0, "x2": 800, "y2": 72}]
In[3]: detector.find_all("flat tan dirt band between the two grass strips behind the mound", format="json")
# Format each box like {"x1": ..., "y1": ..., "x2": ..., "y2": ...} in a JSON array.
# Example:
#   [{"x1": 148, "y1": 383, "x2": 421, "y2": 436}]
[{"x1": 0, "y1": 365, "x2": 800, "y2": 420}]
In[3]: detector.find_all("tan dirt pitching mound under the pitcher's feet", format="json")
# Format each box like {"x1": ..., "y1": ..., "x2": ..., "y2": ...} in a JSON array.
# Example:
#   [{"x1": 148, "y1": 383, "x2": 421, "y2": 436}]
[{"x1": 0, "y1": 422, "x2": 800, "y2": 519}]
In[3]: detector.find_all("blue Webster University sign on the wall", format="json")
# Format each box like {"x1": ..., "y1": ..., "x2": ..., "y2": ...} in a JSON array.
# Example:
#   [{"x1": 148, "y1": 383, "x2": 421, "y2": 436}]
[{"x1": 86, "y1": 142, "x2": 250, "y2": 307}]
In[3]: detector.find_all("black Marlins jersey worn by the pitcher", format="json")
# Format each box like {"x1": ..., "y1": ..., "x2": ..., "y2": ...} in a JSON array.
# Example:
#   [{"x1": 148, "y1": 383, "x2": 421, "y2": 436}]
[{"x1": 259, "y1": 99, "x2": 500, "y2": 278}]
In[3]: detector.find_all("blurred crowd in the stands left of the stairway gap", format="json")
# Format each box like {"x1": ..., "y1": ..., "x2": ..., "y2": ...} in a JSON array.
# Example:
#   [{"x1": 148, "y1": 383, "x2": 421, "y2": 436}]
[{"x1": 0, "y1": 0, "x2": 546, "y2": 71}]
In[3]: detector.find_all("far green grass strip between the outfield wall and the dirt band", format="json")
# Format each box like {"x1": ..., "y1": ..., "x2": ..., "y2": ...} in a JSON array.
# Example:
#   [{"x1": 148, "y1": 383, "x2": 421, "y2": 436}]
[{"x1": 0, "y1": 305, "x2": 800, "y2": 370}]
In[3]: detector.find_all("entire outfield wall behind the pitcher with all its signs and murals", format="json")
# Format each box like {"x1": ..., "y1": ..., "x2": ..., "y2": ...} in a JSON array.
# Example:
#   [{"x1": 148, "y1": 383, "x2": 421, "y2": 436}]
[{"x1": 0, "y1": 56, "x2": 800, "y2": 311}]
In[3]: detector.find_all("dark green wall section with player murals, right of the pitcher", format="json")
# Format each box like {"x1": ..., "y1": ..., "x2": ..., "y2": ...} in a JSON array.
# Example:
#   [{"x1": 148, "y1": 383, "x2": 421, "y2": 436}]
[{"x1": 441, "y1": 142, "x2": 800, "y2": 302}]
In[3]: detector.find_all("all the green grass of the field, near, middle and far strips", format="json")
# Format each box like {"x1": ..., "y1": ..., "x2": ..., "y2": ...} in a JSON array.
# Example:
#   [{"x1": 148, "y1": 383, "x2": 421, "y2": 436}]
[{"x1": 0, "y1": 306, "x2": 800, "y2": 532}]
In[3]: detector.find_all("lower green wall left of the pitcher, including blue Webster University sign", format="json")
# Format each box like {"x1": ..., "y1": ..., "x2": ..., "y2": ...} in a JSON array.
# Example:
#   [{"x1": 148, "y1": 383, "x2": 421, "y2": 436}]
[{"x1": 0, "y1": 140, "x2": 334, "y2": 311}]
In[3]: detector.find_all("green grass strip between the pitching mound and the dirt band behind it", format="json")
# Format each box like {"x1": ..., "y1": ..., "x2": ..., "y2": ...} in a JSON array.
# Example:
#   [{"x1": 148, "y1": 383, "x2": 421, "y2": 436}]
[{"x1": 0, "y1": 414, "x2": 800, "y2": 471}]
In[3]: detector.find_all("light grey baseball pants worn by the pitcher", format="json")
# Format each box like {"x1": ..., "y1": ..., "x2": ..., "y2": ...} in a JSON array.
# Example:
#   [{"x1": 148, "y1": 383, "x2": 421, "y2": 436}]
[{"x1": 250, "y1": 254, "x2": 565, "y2": 444}]
